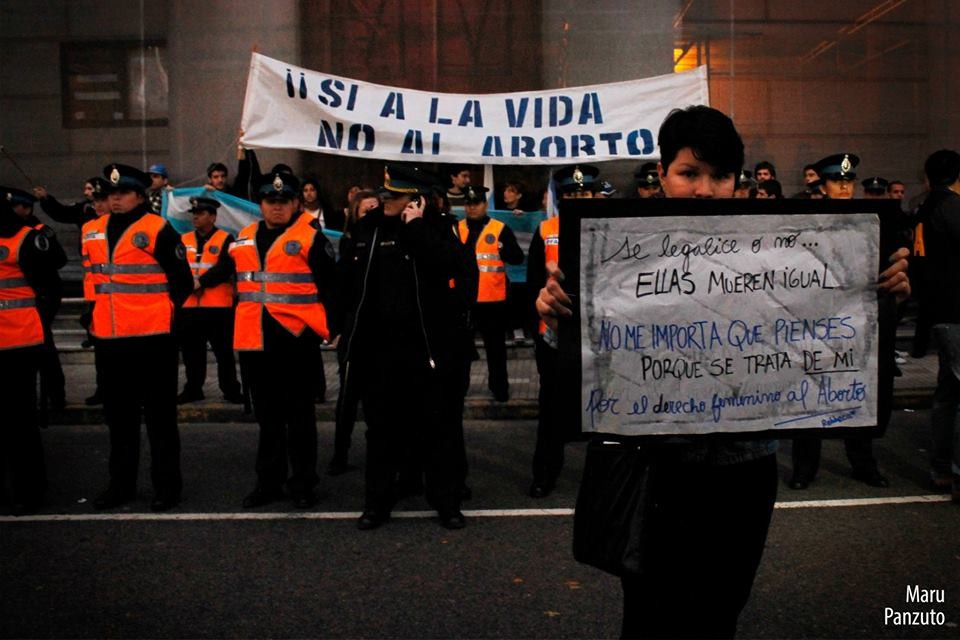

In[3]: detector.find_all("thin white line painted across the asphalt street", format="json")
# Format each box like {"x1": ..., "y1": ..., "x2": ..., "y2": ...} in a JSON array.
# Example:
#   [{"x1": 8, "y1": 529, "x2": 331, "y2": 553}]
[{"x1": 0, "y1": 494, "x2": 950, "y2": 524}]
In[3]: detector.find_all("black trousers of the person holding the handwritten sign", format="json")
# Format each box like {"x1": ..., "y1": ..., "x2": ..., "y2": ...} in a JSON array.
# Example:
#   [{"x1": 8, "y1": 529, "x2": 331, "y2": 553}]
[{"x1": 621, "y1": 455, "x2": 777, "y2": 638}]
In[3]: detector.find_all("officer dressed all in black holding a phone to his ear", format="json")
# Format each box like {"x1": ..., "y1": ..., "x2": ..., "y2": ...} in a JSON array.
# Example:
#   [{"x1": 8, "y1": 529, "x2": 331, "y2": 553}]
[{"x1": 339, "y1": 166, "x2": 469, "y2": 529}]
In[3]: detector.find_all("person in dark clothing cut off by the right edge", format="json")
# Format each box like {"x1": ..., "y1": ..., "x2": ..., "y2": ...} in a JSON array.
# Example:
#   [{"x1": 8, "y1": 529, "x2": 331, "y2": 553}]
[{"x1": 919, "y1": 149, "x2": 960, "y2": 502}]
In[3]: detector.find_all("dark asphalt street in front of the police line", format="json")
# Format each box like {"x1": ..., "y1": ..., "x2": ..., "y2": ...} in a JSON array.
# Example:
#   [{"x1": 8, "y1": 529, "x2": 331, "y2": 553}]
[{"x1": 0, "y1": 410, "x2": 960, "y2": 638}]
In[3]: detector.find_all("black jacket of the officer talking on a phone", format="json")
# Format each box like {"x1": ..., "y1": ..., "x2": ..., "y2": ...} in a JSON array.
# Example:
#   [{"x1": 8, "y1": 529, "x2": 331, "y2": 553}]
[{"x1": 338, "y1": 208, "x2": 477, "y2": 369}]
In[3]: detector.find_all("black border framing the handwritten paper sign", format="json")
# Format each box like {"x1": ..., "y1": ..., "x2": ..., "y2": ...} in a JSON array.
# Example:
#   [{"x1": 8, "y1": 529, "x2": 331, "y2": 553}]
[{"x1": 558, "y1": 198, "x2": 905, "y2": 440}]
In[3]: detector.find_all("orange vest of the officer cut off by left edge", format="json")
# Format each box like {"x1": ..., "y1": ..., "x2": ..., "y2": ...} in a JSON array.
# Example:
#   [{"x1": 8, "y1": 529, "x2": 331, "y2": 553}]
[{"x1": 0, "y1": 227, "x2": 43, "y2": 349}]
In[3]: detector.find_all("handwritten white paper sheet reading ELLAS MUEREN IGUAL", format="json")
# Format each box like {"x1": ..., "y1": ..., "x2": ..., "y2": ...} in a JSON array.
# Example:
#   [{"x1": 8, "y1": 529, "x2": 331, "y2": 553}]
[{"x1": 561, "y1": 213, "x2": 879, "y2": 435}]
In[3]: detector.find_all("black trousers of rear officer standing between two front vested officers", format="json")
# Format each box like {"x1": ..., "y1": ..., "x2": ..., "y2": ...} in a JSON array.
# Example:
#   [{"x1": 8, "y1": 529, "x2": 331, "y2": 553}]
[{"x1": 177, "y1": 308, "x2": 240, "y2": 395}]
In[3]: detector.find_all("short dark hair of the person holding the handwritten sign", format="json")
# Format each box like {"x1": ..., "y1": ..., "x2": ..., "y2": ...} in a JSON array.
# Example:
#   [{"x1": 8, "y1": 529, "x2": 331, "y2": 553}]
[{"x1": 657, "y1": 105, "x2": 743, "y2": 174}]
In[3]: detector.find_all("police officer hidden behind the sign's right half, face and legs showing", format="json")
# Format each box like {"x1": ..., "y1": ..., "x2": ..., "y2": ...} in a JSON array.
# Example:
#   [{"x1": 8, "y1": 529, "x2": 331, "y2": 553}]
[{"x1": 787, "y1": 153, "x2": 896, "y2": 490}]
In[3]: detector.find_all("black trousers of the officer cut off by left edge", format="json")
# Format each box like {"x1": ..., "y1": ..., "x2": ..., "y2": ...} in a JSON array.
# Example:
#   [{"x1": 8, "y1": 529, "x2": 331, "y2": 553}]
[{"x1": 0, "y1": 346, "x2": 47, "y2": 504}]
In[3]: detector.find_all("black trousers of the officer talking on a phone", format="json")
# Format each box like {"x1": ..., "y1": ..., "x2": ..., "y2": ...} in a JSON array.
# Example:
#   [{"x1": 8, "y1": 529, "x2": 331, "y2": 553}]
[{"x1": 360, "y1": 355, "x2": 465, "y2": 513}]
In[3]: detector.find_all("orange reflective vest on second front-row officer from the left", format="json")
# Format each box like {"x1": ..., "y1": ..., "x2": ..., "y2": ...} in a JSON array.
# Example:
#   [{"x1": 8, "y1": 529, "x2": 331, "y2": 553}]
[{"x1": 84, "y1": 214, "x2": 173, "y2": 338}]
